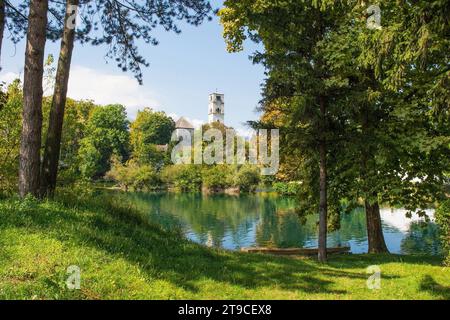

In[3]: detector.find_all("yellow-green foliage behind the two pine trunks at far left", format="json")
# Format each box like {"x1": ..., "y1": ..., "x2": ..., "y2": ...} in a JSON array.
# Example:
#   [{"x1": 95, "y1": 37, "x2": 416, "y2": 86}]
[{"x1": 0, "y1": 80, "x2": 100, "y2": 193}]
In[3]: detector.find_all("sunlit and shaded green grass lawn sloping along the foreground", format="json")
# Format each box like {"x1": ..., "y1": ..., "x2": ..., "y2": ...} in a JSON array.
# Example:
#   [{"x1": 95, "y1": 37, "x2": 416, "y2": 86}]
[{"x1": 0, "y1": 194, "x2": 450, "y2": 299}]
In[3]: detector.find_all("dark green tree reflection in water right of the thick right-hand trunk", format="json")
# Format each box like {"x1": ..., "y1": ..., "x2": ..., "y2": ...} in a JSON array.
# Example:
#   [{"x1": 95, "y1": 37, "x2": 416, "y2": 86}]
[{"x1": 401, "y1": 222, "x2": 442, "y2": 254}]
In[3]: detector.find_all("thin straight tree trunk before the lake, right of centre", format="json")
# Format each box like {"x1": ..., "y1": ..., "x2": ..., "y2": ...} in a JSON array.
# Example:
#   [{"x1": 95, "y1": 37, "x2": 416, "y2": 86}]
[{"x1": 318, "y1": 97, "x2": 328, "y2": 262}]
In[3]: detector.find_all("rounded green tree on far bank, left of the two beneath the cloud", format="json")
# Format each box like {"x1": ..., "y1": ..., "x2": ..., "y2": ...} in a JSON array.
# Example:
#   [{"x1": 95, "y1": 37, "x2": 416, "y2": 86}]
[{"x1": 79, "y1": 105, "x2": 130, "y2": 179}]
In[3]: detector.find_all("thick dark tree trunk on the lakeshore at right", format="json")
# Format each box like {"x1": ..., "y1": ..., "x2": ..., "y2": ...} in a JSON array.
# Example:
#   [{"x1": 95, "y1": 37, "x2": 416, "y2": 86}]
[{"x1": 365, "y1": 200, "x2": 389, "y2": 253}]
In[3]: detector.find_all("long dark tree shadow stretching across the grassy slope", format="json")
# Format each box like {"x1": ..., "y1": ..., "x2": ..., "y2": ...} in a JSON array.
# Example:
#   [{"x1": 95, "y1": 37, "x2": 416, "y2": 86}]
[{"x1": 3, "y1": 199, "x2": 414, "y2": 294}]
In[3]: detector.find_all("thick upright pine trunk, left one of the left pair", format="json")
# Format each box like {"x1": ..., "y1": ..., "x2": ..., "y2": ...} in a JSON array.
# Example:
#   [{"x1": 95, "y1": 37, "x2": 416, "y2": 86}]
[{"x1": 19, "y1": 0, "x2": 48, "y2": 197}]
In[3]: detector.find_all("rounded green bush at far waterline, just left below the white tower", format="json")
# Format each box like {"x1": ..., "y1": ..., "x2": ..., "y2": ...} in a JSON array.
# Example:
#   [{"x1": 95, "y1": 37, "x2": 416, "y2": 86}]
[{"x1": 161, "y1": 164, "x2": 202, "y2": 192}]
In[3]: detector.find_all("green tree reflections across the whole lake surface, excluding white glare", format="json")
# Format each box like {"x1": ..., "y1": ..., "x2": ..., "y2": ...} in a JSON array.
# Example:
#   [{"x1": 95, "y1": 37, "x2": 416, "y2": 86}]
[{"x1": 119, "y1": 193, "x2": 439, "y2": 254}]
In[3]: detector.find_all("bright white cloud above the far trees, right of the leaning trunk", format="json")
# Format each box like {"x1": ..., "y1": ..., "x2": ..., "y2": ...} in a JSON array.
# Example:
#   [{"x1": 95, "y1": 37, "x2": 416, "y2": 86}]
[{"x1": 67, "y1": 66, "x2": 160, "y2": 119}]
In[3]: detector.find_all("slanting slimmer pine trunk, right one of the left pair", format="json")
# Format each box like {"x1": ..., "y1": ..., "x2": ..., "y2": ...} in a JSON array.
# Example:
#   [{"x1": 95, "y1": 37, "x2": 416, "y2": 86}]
[{"x1": 41, "y1": 0, "x2": 79, "y2": 197}]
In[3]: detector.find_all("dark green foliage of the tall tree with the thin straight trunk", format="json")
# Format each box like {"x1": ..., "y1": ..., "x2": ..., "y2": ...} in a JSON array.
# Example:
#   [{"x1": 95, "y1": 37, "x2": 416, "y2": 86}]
[{"x1": 219, "y1": 0, "x2": 351, "y2": 220}]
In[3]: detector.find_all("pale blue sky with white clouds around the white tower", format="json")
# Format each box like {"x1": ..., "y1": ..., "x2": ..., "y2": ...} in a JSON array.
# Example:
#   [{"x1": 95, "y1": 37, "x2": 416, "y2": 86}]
[{"x1": 0, "y1": 0, "x2": 264, "y2": 132}]
